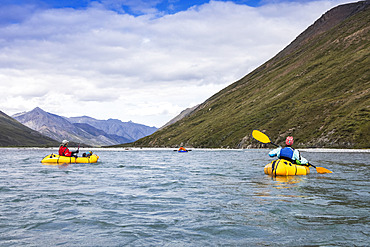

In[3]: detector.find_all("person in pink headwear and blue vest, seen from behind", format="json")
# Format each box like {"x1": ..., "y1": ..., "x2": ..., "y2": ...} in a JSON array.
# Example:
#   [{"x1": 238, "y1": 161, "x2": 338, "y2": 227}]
[{"x1": 269, "y1": 136, "x2": 308, "y2": 165}]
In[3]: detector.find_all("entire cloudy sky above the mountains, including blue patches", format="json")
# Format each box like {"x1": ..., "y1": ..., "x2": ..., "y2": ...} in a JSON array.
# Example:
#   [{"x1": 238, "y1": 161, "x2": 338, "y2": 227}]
[{"x1": 0, "y1": 0, "x2": 357, "y2": 127}]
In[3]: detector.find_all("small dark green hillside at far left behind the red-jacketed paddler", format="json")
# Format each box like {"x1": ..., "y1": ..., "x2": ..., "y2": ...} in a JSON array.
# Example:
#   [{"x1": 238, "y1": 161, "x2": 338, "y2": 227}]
[{"x1": 0, "y1": 111, "x2": 59, "y2": 147}]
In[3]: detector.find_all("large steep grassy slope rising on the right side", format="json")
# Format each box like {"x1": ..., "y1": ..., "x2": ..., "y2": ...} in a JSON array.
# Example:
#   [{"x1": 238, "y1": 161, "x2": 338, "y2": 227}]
[{"x1": 126, "y1": 2, "x2": 370, "y2": 148}]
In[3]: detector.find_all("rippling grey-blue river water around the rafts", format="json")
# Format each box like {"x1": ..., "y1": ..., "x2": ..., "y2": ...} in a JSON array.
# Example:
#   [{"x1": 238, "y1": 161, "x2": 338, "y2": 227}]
[{"x1": 0, "y1": 149, "x2": 370, "y2": 246}]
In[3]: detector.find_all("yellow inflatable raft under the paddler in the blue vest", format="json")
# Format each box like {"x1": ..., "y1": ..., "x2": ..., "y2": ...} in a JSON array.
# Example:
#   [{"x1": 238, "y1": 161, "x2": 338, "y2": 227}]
[{"x1": 264, "y1": 159, "x2": 310, "y2": 176}]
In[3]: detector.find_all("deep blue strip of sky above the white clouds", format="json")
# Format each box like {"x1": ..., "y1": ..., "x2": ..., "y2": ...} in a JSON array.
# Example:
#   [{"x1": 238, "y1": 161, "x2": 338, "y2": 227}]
[{"x1": 0, "y1": 0, "x2": 335, "y2": 23}]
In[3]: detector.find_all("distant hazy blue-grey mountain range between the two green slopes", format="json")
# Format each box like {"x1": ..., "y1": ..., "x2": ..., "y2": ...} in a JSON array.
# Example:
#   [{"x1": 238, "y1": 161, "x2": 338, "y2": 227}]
[{"x1": 12, "y1": 107, "x2": 157, "y2": 146}]
